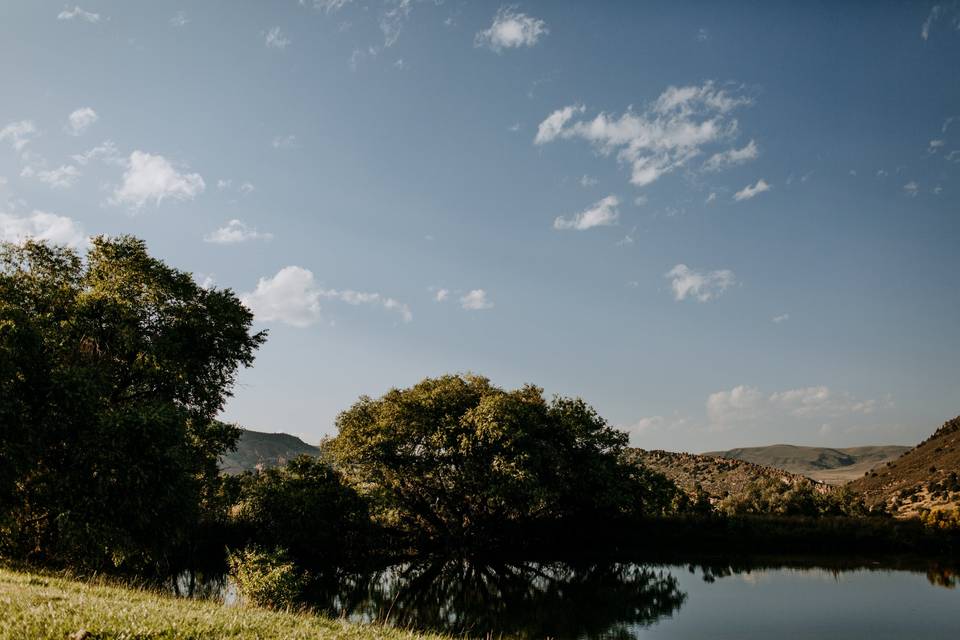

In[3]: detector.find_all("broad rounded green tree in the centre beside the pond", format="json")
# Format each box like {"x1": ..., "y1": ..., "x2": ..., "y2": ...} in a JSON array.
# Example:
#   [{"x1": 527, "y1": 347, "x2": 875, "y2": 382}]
[{"x1": 329, "y1": 375, "x2": 675, "y2": 547}]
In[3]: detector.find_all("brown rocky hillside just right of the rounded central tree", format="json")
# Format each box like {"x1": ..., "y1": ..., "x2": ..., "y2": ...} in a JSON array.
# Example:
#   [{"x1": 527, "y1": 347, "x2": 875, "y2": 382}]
[{"x1": 628, "y1": 449, "x2": 832, "y2": 500}]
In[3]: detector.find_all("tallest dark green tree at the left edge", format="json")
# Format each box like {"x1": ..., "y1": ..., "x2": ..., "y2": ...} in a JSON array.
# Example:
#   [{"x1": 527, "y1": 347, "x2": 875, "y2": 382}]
[{"x1": 0, "y1": 236, "x2": 265, "y2": 571}]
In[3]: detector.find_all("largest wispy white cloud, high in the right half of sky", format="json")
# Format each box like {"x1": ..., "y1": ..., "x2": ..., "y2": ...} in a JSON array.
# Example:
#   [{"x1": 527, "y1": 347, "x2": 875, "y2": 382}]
[{"x1": 534, "y1": 82, "x2": 752, "y2": 187}]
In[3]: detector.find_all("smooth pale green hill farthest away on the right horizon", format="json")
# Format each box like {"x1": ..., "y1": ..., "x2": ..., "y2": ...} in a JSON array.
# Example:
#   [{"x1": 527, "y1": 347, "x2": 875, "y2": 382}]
[{"x1": 703, "y1": 444, "x2": 910, "y2": 485}]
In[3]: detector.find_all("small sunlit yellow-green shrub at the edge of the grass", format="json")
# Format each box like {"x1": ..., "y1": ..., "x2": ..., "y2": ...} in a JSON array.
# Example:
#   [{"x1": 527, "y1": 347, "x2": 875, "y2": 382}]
[{"x1": 228, "y1": 546, "x2": 307, "y2": 609}]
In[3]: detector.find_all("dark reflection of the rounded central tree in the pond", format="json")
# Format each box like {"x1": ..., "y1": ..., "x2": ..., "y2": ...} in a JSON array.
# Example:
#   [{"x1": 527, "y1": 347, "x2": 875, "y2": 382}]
[{"x1": 311, "y1": 560, "x2": 686, "y2": 638}]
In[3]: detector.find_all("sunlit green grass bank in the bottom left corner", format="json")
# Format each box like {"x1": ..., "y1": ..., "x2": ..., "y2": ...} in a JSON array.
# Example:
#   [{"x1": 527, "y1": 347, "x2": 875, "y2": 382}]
[{"x1": 0, "y1": 567, "x2": 439, "y2": 640}]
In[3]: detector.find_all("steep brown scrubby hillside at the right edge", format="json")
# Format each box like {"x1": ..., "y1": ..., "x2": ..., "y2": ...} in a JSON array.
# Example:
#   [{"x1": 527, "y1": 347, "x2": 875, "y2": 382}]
[{"x1": 849, "y1": 416, "x2": 960, "y2": 517}]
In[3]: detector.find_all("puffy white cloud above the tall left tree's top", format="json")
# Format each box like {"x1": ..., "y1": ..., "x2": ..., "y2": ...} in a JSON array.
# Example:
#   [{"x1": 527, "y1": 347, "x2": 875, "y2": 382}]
[{"x1": 110, "y1": 151, "x2": 206, "y2": 209}]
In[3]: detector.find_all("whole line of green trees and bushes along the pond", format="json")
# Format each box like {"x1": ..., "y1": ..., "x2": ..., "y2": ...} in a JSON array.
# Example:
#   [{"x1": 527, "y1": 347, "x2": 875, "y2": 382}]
[{"x1": 0, "y1": 236, "x2": 920, "y2": 601}]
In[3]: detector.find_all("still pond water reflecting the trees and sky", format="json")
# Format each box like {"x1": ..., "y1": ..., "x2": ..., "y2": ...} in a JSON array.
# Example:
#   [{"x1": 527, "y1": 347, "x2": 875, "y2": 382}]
[{"x1": 176, "y1": 561, "x2": 960, "y2": 640}]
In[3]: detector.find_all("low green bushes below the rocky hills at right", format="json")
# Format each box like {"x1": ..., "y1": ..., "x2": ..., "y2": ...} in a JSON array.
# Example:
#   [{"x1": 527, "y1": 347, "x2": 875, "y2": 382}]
[{"x1": 717, "y1": 478, "x2": 878, "y2": 517}]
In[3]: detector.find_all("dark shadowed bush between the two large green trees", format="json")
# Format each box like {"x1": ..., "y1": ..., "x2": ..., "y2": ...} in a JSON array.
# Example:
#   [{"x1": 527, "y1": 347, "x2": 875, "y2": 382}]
[{"x1": 231, "y1": 456, "x2": 372, "y2": 567}]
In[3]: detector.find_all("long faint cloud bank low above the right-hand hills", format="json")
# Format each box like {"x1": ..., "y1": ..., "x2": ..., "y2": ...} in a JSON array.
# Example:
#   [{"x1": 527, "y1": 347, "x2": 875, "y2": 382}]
[{"x1": 706, "y1": 385, "x2": 893, "y2": 428}]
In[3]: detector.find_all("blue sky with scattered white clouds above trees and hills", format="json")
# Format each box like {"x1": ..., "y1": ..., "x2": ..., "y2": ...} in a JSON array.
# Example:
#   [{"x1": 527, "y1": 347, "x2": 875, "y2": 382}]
[{"x1": 0, "y1": 0, "x2": 960, "y2": 452}]
